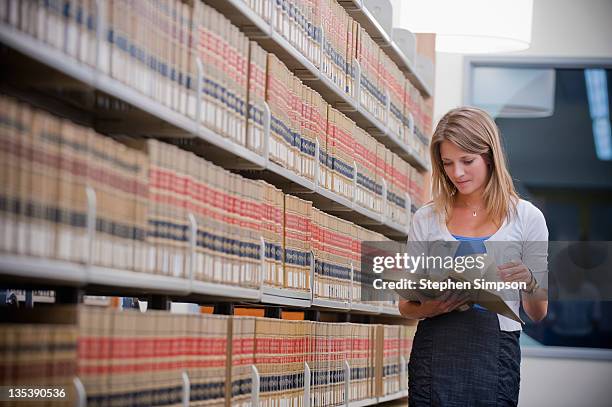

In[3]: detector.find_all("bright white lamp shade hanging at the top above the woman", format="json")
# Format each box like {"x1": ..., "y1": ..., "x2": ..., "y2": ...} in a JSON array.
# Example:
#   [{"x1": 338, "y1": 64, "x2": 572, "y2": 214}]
[{"x1": 391, "y1": 0, "x2": 533, "y2": 53}]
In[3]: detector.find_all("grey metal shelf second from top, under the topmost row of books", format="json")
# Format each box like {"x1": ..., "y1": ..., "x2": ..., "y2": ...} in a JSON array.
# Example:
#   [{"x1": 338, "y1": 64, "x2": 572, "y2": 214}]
[{"x1": 205, "y1": 0, "x2": 430, "y2": 171}]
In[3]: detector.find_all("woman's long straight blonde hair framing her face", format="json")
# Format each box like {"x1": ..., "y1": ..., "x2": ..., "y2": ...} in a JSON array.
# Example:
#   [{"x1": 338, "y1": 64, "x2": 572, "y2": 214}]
[{"x1": 429, "y1": 107, "x2": 519, "y2": 227}]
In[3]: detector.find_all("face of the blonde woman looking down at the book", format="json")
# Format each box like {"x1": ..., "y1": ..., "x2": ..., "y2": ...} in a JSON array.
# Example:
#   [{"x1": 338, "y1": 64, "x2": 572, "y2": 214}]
[{"x1": 440, "y1": 140, "x2": 489, "y2": 195}]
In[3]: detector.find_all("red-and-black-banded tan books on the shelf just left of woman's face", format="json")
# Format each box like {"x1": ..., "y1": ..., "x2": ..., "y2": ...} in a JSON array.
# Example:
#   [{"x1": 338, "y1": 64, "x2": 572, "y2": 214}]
[{"x1": 266, "y1": 50, "x2": 424, "y2": 220}]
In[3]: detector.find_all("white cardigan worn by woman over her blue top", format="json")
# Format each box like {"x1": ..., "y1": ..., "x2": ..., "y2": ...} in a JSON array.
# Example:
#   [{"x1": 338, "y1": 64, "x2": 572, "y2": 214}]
[{"x1": 408, "y1": 199, "x2": 548, "y2": 331}]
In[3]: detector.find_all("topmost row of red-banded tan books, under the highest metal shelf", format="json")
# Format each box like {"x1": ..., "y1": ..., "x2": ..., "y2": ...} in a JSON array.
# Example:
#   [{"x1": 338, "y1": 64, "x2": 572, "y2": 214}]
[{"x1": 244, "y1": 0, "x2": 432, "y2": 161}]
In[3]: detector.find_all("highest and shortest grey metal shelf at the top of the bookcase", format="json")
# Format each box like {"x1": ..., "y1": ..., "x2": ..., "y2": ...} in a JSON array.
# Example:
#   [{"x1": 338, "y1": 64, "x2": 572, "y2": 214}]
[{"x1": 340, "y1": 0, "x2": 433, "y2": 97}]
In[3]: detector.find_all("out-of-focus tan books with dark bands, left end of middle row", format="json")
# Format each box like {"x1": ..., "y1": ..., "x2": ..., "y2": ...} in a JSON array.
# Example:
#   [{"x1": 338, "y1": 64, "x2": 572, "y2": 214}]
[{"x1": 0, "y1": 97, "x2": 149, "y2": 270}]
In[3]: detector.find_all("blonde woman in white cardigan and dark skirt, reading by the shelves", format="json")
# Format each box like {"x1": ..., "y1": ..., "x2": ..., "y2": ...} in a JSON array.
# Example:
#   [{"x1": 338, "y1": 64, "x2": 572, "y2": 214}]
[{"x1": 399, "y1": 107, "x2": 548, "y2": 407}]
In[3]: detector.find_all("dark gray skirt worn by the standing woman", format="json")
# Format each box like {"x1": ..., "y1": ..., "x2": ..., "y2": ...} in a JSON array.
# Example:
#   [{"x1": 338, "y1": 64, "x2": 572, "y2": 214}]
[{"x1": 408, "y1": 308, "x2": 521, "y2": 407}]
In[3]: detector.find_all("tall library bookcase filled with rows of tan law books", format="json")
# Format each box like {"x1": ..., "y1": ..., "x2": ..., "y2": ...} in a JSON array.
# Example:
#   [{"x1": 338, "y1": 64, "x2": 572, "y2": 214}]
[{"x1": 0, "y1": 0, "x2": 435, "y2": 407}]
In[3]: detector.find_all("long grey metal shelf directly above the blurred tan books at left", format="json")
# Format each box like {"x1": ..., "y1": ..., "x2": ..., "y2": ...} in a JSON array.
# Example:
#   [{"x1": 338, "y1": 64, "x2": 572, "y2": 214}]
[{"x1": 0, "y1": 24, "x2": 414, "y2": 238}]
